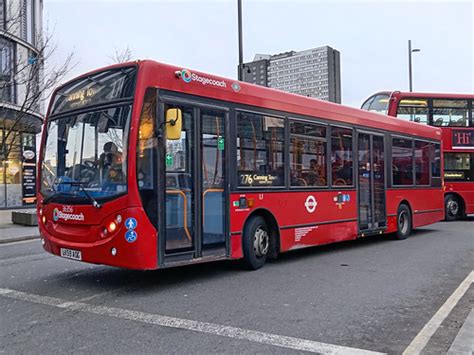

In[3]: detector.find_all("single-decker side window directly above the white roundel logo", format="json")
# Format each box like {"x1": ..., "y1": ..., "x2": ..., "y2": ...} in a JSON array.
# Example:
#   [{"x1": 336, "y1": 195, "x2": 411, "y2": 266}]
[{"x1": 290, "y1": 122, "x2": 327, "y2": 186}]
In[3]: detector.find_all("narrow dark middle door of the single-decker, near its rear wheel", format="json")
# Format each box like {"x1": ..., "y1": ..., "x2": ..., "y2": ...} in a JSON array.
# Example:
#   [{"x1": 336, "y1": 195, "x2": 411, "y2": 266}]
[{"x1": 357, "y1": 132, "x2": 386, "y2": 235}]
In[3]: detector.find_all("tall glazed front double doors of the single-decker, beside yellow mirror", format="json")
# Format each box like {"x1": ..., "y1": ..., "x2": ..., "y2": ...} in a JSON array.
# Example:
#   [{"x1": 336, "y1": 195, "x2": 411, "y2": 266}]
[{"x1": 159, "y1": 103, "x2": 228, "y2": 265}]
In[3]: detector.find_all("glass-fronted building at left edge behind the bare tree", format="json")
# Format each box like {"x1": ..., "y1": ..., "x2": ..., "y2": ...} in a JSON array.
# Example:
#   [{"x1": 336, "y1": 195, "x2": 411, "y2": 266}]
[{"x1": 0, "y1": 0, "x2": 43, "y2": 209}]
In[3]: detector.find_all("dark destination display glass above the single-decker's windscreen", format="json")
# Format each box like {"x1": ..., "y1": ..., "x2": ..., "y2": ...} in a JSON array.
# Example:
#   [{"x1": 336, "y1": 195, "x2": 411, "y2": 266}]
[{"x1": 51, "y1": 67, "x2": 137, "y2": 115}]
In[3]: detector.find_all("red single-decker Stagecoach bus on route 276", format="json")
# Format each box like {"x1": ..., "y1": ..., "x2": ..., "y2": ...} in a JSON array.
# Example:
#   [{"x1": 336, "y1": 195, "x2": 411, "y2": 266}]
[{"x1": 38, "y1": 61, "x2": 443, "y2": 269}]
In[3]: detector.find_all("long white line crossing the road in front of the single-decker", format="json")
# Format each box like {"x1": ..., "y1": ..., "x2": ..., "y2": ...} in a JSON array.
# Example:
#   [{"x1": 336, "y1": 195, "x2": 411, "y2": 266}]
[{"x1": 0, "y1": 288, "x2": 382, "y2": 355}]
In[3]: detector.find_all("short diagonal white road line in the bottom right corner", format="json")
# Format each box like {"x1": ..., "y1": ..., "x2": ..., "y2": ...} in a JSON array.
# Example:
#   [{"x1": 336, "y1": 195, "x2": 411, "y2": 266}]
[{"x1": 403, "y1": 271, "x2": 474, "y2": 355}]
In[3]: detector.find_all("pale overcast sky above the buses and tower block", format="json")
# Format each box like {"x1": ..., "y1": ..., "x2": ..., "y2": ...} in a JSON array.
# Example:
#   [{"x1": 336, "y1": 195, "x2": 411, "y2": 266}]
[{"x1": 44, "y1": 0, "x2": 474, "y2": 107}]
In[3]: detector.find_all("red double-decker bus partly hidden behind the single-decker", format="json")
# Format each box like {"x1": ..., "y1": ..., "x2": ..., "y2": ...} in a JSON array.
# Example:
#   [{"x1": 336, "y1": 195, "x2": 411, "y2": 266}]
[{"x1": 362, "y1": 91, "x2": 474, "y2": 221}]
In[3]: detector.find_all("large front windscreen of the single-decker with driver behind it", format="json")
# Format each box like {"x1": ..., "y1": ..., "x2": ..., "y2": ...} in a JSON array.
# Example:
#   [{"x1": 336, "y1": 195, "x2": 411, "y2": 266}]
[{"x1": 41, "y1": 105, "x2": 131, "y2": 203}]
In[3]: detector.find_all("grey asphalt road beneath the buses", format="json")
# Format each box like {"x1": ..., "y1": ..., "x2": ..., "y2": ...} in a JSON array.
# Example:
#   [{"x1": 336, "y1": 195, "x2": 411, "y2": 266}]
[{"x1": 0, "y1": 218, "x2": 474, "y2": 354}]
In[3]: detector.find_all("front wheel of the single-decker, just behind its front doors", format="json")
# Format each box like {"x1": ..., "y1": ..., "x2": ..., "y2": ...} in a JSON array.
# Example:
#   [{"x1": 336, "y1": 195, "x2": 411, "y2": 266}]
[{"x1": 242, "y1": 216, "x2": 270, "y2": 270}]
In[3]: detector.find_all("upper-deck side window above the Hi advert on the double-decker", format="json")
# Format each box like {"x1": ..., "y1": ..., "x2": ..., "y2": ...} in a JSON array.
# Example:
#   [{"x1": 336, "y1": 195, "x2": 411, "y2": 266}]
[{"x1": 433, "y1": 99, "x2": 469, "y2": 127}]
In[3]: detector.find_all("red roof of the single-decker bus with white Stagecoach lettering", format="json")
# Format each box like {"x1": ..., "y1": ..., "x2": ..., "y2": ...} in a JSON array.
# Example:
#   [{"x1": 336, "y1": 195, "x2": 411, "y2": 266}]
[{"x1": 50, "y1": 60, "x2": 441, "y2": 140}]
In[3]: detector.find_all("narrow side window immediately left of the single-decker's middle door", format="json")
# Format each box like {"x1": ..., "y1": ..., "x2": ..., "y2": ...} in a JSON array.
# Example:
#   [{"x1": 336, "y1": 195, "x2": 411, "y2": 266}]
[{"x1": 331, "y1": 127, "x2": 353, "y2": 186}]
